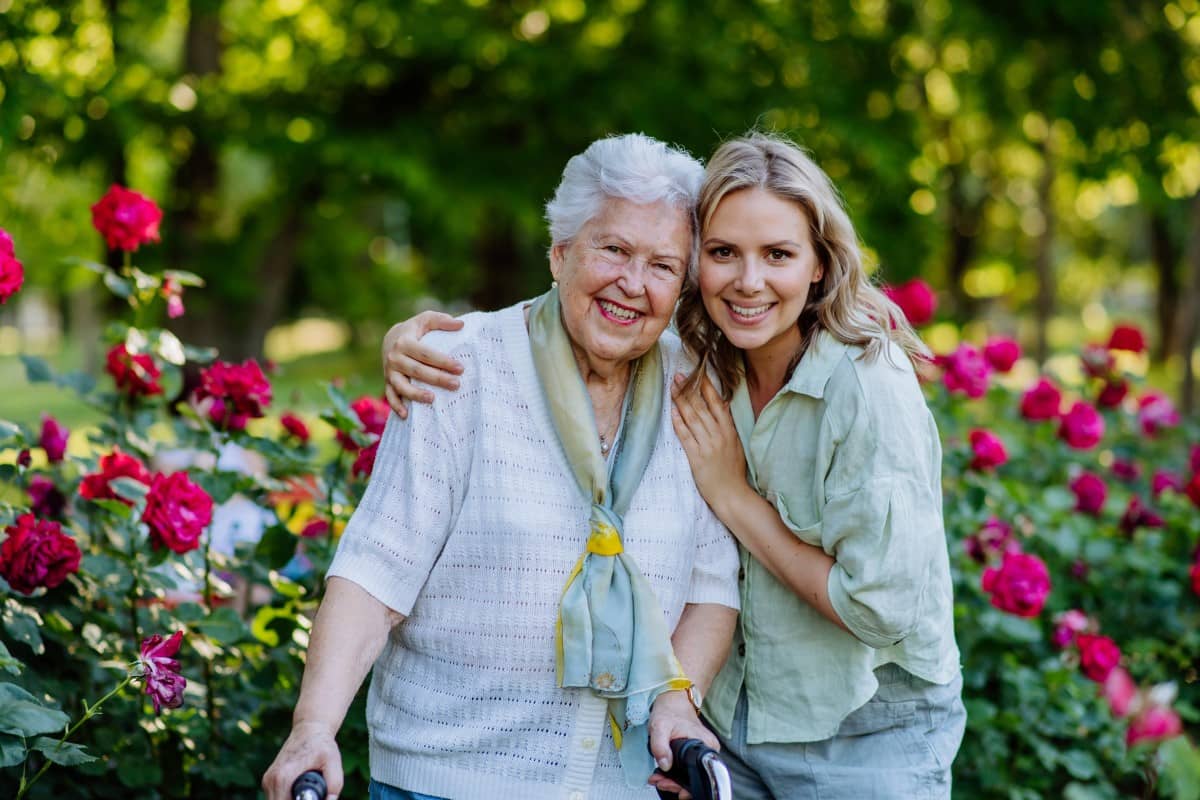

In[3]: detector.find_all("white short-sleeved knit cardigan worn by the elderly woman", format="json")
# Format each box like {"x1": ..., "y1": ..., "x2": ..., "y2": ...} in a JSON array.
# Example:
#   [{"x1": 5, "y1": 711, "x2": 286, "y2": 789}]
[{"x1": 329, "y1": 305, "x2": 738, "y2": 800}]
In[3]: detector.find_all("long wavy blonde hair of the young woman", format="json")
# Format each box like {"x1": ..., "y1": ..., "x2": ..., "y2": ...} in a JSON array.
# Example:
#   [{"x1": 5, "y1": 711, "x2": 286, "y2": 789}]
[{"x1": 676, "y1": 131, "x2": 930, "y2": 401}]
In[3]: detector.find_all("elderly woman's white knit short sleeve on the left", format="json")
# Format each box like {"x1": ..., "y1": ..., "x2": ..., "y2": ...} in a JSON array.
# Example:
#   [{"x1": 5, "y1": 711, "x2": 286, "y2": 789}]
[{"x1": 328, "y1": 354, "x2": 469, "y2": 616}]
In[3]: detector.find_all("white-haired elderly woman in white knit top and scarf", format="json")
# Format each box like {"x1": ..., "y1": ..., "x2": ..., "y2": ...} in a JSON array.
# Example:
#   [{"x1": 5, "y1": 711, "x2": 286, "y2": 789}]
[{"x1": 263, "y1": 136, "x2": 738, "y2": 800}]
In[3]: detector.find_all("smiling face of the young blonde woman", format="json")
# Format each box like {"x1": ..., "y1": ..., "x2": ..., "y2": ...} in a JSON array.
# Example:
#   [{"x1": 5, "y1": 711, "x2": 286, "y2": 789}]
[{"x1": 700, "y1": 188, "x2": 822, "y2": 360}]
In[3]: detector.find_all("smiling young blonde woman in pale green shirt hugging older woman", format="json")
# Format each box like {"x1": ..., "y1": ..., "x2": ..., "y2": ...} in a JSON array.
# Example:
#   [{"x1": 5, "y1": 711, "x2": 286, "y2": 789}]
[{"x1": 385, "y1": 133, "x2": 966, "y2": 800}]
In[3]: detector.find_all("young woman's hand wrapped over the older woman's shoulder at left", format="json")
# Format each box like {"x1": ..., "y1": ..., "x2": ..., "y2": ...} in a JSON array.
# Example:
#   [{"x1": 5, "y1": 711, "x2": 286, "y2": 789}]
[{"x1": 382, "y1": 311, "x2": 462, "y2": 420}]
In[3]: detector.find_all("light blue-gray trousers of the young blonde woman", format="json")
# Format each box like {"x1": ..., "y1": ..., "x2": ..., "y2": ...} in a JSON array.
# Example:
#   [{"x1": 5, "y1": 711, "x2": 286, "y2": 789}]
[{"x1": 720, "y1": 664, "x2": 967, "y2": 800}]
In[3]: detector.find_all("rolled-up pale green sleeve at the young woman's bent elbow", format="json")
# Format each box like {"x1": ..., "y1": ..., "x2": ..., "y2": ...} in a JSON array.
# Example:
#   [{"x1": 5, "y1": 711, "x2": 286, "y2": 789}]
[{"x1": 823, "y1": 476, "x2": 944, "y2": 648}]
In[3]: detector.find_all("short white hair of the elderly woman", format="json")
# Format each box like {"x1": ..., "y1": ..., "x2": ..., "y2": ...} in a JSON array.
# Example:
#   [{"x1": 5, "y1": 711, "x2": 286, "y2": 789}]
[{"x1": 546, "y1": 133, "x2": 704, "y2": 260}]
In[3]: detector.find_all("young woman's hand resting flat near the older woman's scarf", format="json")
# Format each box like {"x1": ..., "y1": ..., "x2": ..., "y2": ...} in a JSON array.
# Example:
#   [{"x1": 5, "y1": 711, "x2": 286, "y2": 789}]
[{"x1": 671, "y1": 375, "x2": 749, "y2": 519}]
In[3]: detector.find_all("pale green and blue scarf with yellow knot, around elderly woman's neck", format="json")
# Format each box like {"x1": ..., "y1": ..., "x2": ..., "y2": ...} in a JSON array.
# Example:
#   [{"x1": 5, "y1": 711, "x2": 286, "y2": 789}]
[{"x1": 529, "y1": 288, "x2": 691, "y2": 786}]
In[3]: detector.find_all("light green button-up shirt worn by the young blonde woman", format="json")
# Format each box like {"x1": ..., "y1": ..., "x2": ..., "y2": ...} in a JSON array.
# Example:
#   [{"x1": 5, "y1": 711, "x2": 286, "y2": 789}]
[{"x1": 704, "y1": 332, "x2": 959, "y2": 744}]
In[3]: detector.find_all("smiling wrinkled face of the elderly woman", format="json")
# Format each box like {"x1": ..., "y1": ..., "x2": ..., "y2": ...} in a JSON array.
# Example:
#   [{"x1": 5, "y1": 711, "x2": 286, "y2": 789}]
[{"x1": 550, "y1": 198, "x2": 691, "y2": 362}]
